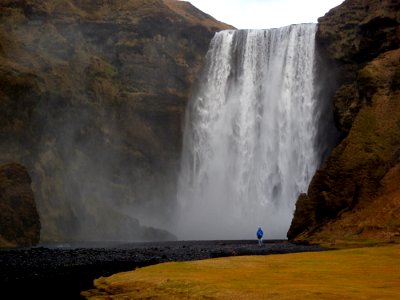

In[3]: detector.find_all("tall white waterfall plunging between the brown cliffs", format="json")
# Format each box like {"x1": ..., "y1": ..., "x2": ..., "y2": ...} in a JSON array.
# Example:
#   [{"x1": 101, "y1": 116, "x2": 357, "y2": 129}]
[{"x1": 176, "y1": 24, "x2": 319, "y2": 239}]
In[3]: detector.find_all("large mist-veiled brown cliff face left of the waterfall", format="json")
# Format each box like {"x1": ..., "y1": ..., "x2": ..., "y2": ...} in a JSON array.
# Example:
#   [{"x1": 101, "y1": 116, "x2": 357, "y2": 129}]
[{"x1": 0, "y1": 0, "x2": 229, "y2": 241}]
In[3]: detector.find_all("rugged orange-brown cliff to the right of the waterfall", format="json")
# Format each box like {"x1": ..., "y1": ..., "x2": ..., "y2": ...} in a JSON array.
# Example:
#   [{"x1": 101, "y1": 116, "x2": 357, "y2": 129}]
[{"x1": 288, "y1": 0, "x2": 400, "y2": 242}]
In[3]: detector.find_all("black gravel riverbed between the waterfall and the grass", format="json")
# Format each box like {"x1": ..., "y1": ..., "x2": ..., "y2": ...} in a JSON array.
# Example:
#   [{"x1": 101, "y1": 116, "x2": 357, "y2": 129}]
[{"x1": 0, "y1": 240, "x2": 326, "y2": 299}]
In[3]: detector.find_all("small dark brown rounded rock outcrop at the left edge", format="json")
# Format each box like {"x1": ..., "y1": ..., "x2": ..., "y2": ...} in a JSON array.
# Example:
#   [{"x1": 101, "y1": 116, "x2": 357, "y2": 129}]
[{"x1": 0, "y1": 163, "x2": 40, "y2": 247}]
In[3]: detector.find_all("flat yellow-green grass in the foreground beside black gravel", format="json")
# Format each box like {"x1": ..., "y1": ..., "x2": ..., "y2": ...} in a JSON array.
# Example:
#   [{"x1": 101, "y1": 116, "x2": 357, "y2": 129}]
[{"x1": 82, "y1": 245, "x2": 400, "y2": 300}]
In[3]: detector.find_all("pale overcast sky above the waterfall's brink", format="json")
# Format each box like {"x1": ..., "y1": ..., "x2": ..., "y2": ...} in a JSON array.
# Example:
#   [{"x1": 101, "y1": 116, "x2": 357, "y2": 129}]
[{"x1": 184, "y1": 0, "x2": 343, "y2": 29}]
